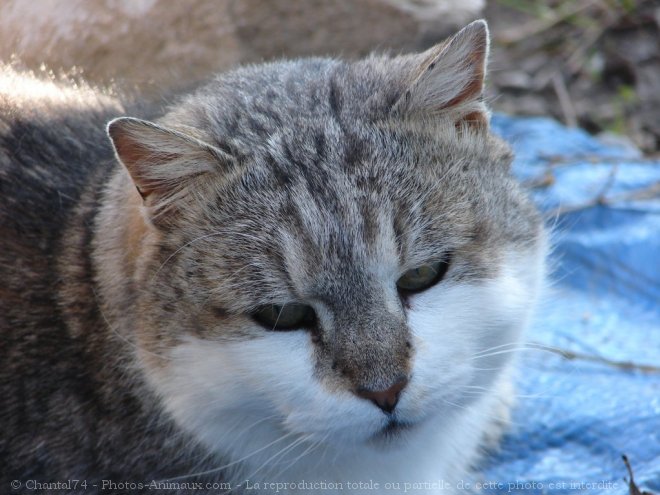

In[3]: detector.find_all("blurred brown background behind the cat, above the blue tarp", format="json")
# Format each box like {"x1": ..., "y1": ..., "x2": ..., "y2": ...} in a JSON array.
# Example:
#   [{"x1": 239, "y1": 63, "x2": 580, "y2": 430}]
[{"x1": 0, "y1": 0, "x2": 660, "y2": 155}]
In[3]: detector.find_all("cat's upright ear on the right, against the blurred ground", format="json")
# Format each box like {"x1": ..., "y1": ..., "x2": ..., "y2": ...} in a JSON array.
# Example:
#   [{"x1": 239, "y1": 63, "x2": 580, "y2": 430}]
[{"x1": 392, "y1": 20, "x2": 490, "y2": 128}]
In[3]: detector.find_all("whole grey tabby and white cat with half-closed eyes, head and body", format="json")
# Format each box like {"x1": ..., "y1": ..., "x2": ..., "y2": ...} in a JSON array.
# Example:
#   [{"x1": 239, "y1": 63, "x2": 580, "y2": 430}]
[{"x1": 0, "y1": 21, "x2": 546, "y2": 493}]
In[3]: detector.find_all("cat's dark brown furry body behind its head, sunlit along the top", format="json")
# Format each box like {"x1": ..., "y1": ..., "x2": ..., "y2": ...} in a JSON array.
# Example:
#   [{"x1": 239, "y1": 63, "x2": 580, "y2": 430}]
[{"x1": 0, "y1": 68, "x2": 214, "y2": 486}]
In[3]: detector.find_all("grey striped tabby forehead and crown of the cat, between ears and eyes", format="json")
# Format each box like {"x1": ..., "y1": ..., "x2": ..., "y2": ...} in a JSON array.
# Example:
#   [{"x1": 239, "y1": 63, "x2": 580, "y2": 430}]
[{"x1": 161, "y1": 60, "x2": 536, "y2": 300}]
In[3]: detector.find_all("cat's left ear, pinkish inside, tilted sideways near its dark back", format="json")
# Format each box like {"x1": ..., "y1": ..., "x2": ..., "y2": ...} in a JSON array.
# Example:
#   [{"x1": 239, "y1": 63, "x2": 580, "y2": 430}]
[{"x1": 107, "y1": 117, "x2": 234, "y2": 219}]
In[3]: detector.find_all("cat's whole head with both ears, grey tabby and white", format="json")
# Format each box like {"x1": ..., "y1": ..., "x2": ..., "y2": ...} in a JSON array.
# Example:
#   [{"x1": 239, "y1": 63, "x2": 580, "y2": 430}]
[{"x1": 109, "y1": 21, "x2": 544, "y2": 449}]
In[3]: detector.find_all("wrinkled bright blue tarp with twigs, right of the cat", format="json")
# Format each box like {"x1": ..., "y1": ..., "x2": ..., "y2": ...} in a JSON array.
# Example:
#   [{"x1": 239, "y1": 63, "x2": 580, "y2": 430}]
[{"x1": 483, "y1": 115, "x2": 660, "y2": 495}]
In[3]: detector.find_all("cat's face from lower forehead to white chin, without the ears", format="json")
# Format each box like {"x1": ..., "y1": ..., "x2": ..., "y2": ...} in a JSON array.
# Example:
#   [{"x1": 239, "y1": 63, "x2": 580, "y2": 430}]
[{"x1": 135, "y1": 129, "x2": 539, "y2": 450}]
